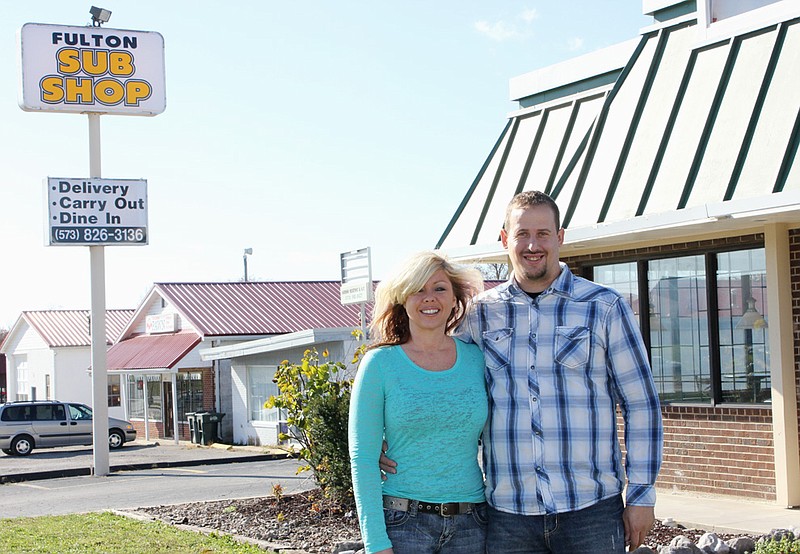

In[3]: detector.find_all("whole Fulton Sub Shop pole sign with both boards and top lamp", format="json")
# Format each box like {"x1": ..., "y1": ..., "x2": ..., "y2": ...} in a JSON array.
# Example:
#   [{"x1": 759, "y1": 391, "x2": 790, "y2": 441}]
[{"x1": 19, "y1": 6, "x2": 166, "y2": 476}]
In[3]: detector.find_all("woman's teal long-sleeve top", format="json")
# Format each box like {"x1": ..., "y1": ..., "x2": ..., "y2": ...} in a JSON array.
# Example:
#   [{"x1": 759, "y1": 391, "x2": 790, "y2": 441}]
[{"x1": 349, "y1": 340, "x2": 488, "y2": 553}]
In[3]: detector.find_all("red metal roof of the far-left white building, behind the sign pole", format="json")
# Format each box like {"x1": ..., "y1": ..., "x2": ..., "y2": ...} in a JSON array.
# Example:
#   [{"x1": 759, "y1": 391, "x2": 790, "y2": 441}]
[{"x1": 22, "y1": 310, "x2": 134, "y2": 347}]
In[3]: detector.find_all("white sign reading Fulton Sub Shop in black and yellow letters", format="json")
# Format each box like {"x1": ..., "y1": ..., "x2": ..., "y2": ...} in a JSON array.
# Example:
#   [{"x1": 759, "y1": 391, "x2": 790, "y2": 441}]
[{"x1": 19, "y1": 23, "x2": 167, "y2": 115}]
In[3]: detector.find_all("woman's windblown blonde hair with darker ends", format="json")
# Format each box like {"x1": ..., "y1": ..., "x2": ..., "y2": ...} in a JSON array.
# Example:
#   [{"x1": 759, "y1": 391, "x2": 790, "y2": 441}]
[{"x1": 370, "y1": 252, "x2": 483, "y2": 347}]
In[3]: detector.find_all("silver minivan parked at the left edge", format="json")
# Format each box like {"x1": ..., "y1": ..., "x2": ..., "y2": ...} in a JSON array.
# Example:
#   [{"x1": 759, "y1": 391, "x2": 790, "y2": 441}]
[{"x1": 0, "y1": 400, "x2": 136, "y2": 456}]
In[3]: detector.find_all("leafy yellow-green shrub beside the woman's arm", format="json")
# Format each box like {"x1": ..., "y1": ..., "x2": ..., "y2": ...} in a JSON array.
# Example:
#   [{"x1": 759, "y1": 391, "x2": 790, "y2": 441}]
[{"x1": 264, "y1": 336, "x2": 365, "y2": 505}]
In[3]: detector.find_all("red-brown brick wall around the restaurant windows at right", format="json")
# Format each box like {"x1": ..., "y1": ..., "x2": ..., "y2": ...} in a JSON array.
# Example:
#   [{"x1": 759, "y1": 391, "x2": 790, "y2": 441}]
[{"x1": 564, "y1": 230, "x2": 800, "y2": 501}]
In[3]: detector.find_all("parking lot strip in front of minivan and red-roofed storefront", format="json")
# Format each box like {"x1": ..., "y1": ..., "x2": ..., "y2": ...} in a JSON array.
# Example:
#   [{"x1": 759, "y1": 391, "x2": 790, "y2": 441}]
[{"x1": 0, "y1": 440, "x2": 288, "y2": 483}]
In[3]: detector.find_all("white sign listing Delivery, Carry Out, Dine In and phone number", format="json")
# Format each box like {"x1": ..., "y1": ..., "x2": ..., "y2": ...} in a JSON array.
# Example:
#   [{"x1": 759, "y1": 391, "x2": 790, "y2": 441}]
[{"x1": 46, "y1": 177, "x2": 148, "y2": 246}]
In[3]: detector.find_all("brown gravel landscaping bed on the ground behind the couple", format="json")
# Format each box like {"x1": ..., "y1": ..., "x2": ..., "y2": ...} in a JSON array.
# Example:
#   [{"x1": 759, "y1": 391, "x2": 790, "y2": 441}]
[{"x1": 131, "y1": 490, "x2": 757, "y2": 554}]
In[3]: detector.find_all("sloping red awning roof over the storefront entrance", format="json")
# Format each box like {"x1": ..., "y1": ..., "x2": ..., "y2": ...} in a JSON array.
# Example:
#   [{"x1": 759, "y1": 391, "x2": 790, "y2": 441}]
[{"x1": 106, "y1": 332, "x2": 200, "y2": 370}]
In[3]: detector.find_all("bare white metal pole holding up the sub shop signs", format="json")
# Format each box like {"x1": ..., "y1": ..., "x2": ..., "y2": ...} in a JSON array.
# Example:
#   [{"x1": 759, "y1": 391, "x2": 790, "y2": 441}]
[{"x1": 88, "y1": 113, "x2": 110, "y2": 477}]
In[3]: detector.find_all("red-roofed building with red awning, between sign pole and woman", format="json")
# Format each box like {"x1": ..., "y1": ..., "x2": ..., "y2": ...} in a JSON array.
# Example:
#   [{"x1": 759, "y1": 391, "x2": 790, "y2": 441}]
[{"x1": 107, "y1": 281, "x2": 368, "y2": 445}]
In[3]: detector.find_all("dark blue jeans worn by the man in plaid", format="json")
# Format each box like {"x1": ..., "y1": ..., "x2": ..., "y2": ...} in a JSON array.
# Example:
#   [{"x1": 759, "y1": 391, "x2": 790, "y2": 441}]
[{"x1": 486, "y1": 496, "x2": 625, "y2": 554}]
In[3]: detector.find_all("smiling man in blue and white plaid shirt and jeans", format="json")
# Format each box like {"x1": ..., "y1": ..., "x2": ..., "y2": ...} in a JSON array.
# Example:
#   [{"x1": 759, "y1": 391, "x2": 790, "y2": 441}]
[{"x1": 461, "y1": 191, "x2": 662, "y2": 554}]
